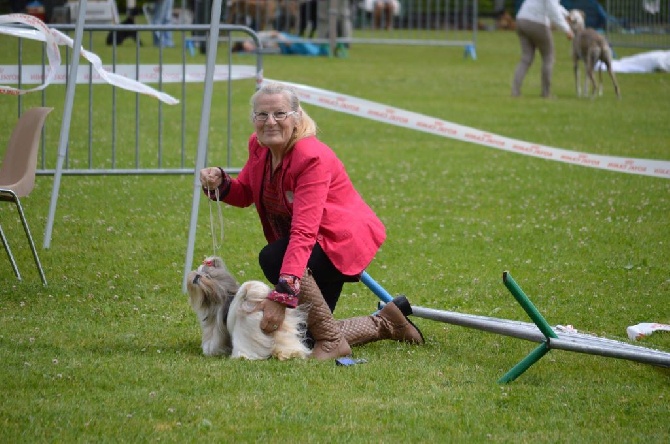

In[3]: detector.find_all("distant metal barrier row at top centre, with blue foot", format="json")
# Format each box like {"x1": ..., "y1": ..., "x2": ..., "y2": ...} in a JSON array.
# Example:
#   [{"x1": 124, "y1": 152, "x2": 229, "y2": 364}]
[{"x1": 194, "y1": 0, "x2": 479, "y2": 50}]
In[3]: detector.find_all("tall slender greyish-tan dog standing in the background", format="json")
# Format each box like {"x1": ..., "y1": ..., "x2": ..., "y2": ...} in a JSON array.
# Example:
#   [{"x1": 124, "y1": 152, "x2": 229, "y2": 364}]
[{"x1": 567, "y1": 9, "x2": 621, "y2": 98}]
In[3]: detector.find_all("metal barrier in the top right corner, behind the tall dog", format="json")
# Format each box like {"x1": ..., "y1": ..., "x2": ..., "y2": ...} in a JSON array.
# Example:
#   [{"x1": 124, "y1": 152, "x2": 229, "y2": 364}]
[{"x1": 606, "y1": 0, "x2": 670, "y2": 49}]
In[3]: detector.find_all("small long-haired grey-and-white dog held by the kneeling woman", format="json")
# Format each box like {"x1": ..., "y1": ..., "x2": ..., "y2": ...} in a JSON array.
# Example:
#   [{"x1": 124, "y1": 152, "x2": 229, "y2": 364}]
[{"x1": 187, "y1": 256, "x2": 311, "y2": 360}]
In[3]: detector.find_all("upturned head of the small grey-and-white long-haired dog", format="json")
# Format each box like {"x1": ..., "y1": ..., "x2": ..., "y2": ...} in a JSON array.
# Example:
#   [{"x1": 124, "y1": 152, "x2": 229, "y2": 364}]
[{"x1": 186, "y1": 256, "x2": 239, "y2": 316}]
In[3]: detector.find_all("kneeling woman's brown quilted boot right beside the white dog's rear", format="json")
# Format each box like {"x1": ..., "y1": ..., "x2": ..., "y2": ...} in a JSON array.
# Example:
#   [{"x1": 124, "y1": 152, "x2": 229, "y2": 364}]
[{"x1": 298, "y1": 270, "x2": 351, "y2": 361}]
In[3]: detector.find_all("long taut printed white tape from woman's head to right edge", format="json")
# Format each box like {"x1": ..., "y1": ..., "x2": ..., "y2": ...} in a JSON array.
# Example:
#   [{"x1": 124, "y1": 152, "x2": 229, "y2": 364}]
[{"x1": 268, "y1": 82, "x2": 670, "y2": 179}]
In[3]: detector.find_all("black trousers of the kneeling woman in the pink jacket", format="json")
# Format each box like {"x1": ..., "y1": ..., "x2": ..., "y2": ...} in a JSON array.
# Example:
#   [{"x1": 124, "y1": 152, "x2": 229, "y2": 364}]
[{"x1": 258, "y1": 237, "x2": 358, "y2": 312}]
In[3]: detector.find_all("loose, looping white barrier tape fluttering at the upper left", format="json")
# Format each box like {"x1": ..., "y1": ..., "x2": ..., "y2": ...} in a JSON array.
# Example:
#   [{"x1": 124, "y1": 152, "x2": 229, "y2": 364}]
[{"x1": 0, "y1": 14, "x2": 179, "y2": 105}]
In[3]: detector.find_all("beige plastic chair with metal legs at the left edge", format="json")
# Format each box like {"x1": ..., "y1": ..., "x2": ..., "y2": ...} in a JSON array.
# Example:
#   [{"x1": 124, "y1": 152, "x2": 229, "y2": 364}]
[{"x1": 0, "y1": 107, "x2": 53, "y2": 286}]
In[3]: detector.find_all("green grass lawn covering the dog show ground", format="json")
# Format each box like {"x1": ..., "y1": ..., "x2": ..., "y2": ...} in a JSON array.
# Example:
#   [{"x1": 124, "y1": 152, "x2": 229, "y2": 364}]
[{"x1": 0, "y1": 32, "x2": 670, "y2": 443}]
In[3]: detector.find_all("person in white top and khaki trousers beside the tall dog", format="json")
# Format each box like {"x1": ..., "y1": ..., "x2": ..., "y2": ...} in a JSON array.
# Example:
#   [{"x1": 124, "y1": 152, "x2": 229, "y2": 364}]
[{"x1": 512, "y1": 0, "x2": 574, "y2": 98}]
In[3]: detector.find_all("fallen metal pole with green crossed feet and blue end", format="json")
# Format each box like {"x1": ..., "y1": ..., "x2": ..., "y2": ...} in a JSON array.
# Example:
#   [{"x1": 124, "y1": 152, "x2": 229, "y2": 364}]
[{"x1": 361, "y1": 271, "x2": 670, "y2": 383}]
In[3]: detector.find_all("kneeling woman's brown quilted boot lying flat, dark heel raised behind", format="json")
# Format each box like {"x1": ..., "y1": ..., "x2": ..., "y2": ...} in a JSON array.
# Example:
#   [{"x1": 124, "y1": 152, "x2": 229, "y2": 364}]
[{"x1": 338, "y1": 296, "x2": 424, "y2": 345}]
